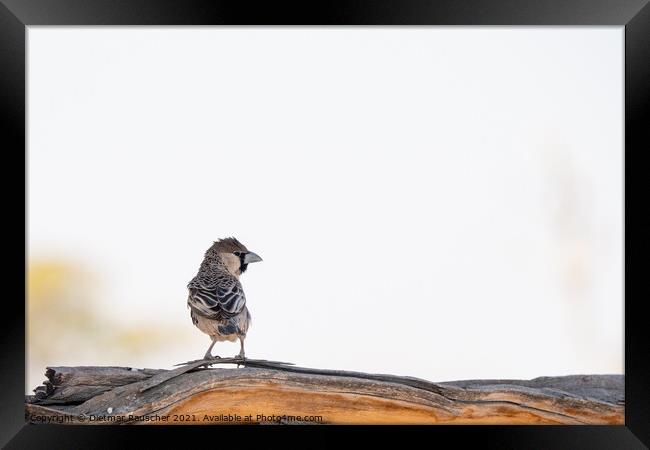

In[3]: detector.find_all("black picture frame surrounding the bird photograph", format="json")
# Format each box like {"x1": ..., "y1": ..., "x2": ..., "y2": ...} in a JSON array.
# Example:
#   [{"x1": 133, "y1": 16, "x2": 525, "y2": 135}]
[{"x1": 0, "y1": 0, "x2": 650, "y2": 449}]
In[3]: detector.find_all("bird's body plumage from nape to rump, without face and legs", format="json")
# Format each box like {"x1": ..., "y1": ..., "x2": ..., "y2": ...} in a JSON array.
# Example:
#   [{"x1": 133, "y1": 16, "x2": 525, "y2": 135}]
[{"x1": 187, "y1": 250, "x2": 250, "y2": 340}]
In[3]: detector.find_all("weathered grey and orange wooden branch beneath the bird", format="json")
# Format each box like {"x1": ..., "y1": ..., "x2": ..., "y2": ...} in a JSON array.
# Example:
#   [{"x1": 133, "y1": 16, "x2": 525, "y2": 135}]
[{"x1": 26, "y1": 359, "x2": 624, "y2": 424}]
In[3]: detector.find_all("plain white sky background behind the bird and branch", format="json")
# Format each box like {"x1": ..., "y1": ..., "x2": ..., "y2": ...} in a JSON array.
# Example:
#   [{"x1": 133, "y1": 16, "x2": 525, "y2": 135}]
[{"x1": 28, "y1": 27, "x2": 623, "y2": 387}]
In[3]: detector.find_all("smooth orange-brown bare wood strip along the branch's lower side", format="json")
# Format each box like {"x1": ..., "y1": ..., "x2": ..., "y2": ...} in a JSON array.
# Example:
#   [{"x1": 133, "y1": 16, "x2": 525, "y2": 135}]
[{"x1": 157, "y1": 386, "x2": 623, "y2": 425}]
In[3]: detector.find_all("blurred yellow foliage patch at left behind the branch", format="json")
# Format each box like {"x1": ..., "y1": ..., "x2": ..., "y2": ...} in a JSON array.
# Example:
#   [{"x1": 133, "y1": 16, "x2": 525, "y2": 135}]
[{"x1": 26, "y1": 260, "x2": 191, "y2": 392}]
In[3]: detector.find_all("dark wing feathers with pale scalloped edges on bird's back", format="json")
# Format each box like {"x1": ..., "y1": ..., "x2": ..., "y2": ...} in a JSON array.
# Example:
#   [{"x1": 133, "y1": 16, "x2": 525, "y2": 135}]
[{"x1": 187, "y1": 275, "x2": 246, "y2": 319}]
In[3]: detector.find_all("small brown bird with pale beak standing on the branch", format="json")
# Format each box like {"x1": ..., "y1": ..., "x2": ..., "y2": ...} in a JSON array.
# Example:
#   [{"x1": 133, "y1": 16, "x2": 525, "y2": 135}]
[{"x1": 187, "y1": 237, "x2": 262, "y2": 359}]
